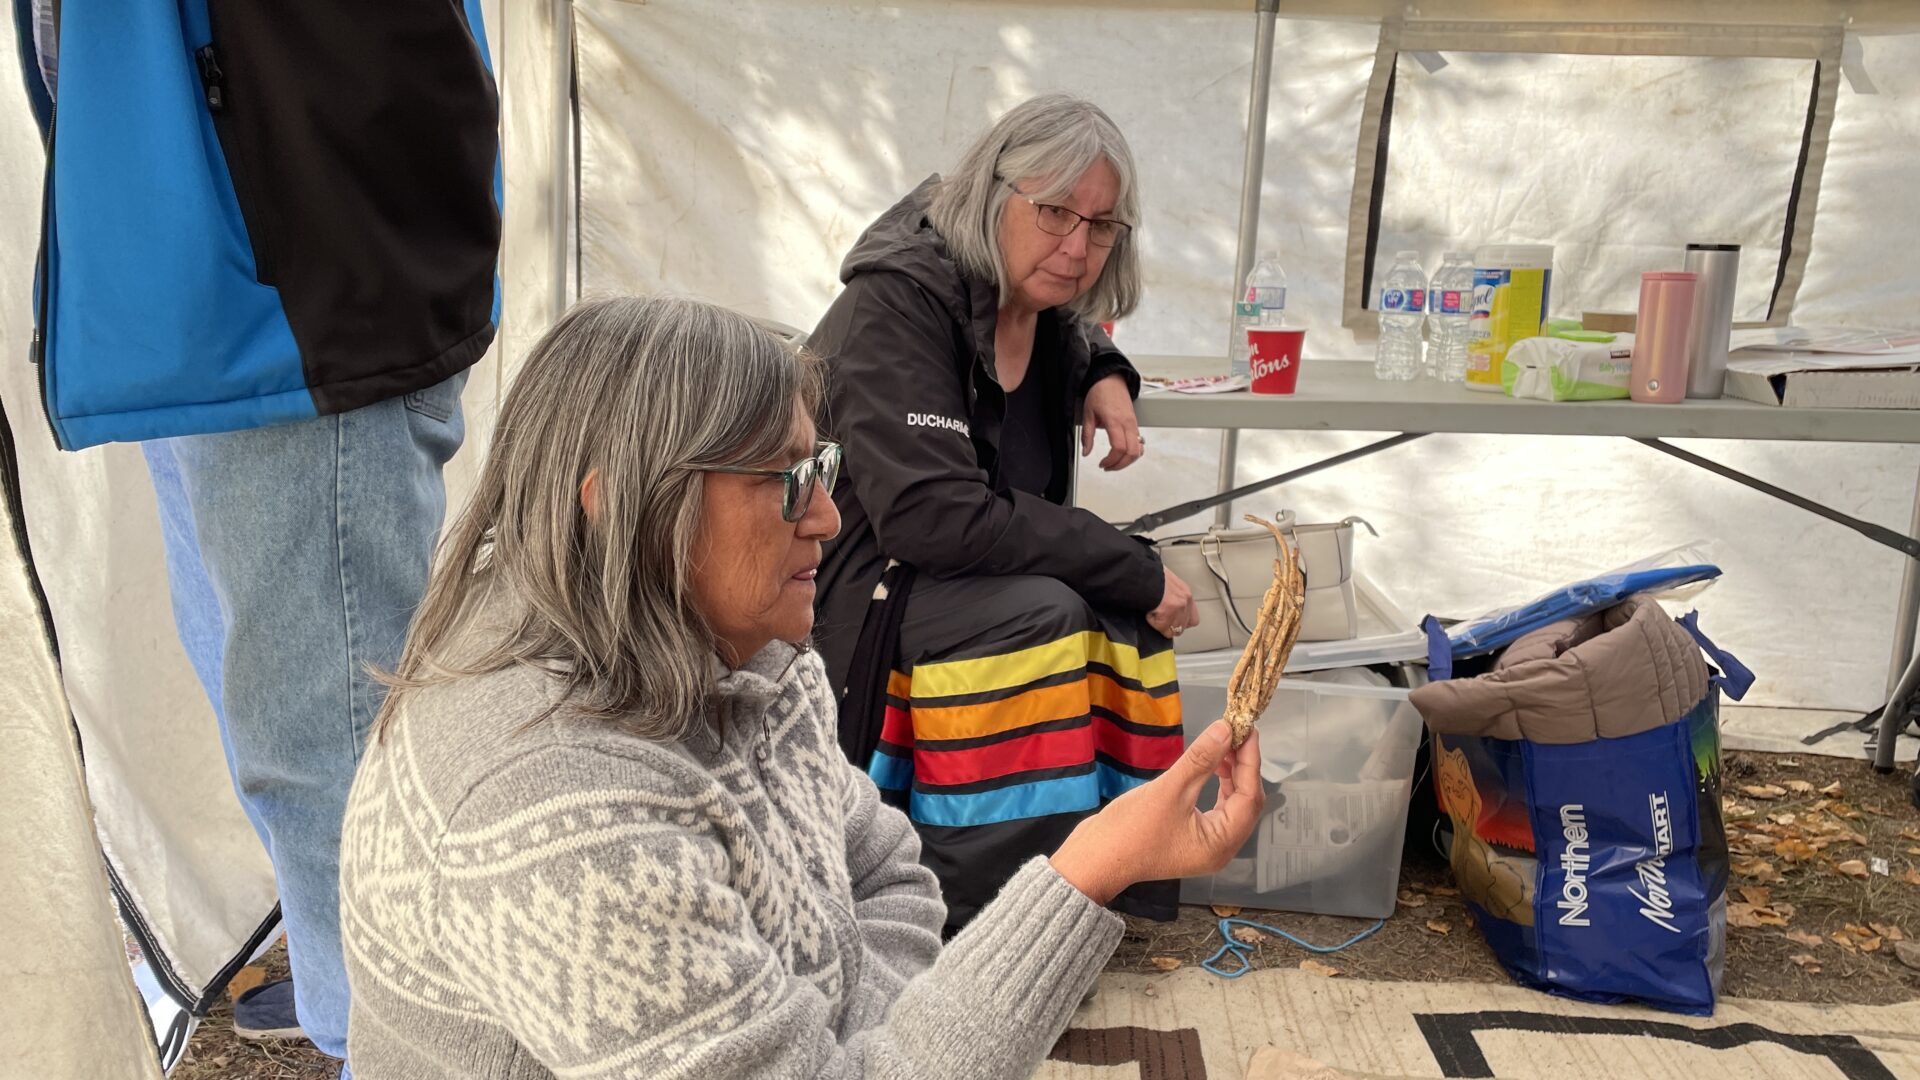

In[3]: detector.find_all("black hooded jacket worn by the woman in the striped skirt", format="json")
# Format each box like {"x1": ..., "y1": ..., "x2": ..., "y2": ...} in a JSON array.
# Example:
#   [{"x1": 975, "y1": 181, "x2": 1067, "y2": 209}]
[{"x1": 808, "y1": 177, "x2": 1165, "y2": 692}]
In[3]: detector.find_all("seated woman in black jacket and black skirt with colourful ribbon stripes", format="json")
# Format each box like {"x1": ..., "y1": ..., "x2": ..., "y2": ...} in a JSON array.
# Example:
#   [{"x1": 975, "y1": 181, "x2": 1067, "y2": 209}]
[{"x1": 808, "y1": 94, "x2": 1196, "y2": 932}]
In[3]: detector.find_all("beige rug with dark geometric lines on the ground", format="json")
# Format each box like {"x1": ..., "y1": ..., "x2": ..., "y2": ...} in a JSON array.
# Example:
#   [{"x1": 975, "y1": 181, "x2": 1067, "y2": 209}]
[{"x1": 1035, "y1": 969, "x2": 1920, "y2": 1080}]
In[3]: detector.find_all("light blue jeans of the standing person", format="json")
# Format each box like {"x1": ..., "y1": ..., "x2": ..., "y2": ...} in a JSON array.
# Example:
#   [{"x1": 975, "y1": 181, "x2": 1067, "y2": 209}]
[{"x1": 144, "y1": 373, "x2": 467, "y2": 1057}]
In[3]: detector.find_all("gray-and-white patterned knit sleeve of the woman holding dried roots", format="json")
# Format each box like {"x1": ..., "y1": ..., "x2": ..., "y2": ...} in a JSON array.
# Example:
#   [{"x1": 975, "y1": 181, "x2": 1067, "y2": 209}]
[{"x1": 432, "y1": 746, "x2": 1121, "y2": 1080}]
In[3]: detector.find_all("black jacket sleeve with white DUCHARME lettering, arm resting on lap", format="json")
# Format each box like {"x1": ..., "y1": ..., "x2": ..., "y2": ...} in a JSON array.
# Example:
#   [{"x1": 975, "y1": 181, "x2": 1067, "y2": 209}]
[{"x1": 810, "y1": 273, "x2": 1165, "y2": 611}]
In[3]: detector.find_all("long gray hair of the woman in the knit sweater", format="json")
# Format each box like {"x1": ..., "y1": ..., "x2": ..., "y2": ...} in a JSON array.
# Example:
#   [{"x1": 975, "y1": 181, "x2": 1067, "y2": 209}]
[{"x1": 374, "y1": 298, "x2": 820, "y2": 740}]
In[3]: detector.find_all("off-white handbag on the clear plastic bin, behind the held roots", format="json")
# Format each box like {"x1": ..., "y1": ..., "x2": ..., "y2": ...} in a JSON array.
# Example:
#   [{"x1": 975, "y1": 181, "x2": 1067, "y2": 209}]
[{"x1": 1154, "y1": 509, "x2": 1379, "y2": 653}]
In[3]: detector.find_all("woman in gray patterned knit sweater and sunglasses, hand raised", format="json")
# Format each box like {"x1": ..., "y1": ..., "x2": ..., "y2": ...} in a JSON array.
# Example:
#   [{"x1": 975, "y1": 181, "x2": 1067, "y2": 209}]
[{"x1": 340, "y1": 300, "x2": 1261, "y2": 1080}]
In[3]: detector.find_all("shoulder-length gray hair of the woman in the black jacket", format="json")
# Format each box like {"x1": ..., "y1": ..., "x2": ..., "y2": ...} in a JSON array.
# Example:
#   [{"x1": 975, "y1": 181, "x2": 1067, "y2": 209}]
[{"x1": 927, "y1": 94, "x2": 1140, "y2": 323}]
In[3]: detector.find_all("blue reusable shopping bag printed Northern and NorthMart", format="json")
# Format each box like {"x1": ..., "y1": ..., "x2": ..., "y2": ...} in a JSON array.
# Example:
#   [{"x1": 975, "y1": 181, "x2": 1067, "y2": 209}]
[{"x1": 1434, "y1": 615, "x2": 1753, "y2": 1015}]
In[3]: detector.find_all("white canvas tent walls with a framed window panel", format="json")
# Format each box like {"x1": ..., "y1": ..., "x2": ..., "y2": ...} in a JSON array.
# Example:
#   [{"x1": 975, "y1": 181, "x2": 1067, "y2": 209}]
[{"x1": 0, "y1": 0, "x2": 1920, "y2": 1078}]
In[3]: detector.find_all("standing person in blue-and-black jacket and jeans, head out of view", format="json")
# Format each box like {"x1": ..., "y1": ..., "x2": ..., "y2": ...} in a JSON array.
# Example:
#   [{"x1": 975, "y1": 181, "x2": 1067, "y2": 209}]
[{"x1": 15, "y1": 0, "x2": 499, "y2": 1057}]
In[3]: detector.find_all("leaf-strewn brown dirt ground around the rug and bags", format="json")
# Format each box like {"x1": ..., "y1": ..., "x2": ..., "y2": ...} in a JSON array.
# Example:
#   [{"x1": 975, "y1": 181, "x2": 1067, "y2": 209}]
[{"x1": 173, "y1": 751, "x2": 1920, "y2": 1080}]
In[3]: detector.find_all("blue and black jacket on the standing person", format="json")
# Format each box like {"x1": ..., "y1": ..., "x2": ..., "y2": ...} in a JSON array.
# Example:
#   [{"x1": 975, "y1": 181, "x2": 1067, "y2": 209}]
[{"x1": 13, "y1": 0, "x2": 499, "y2": 450}]
